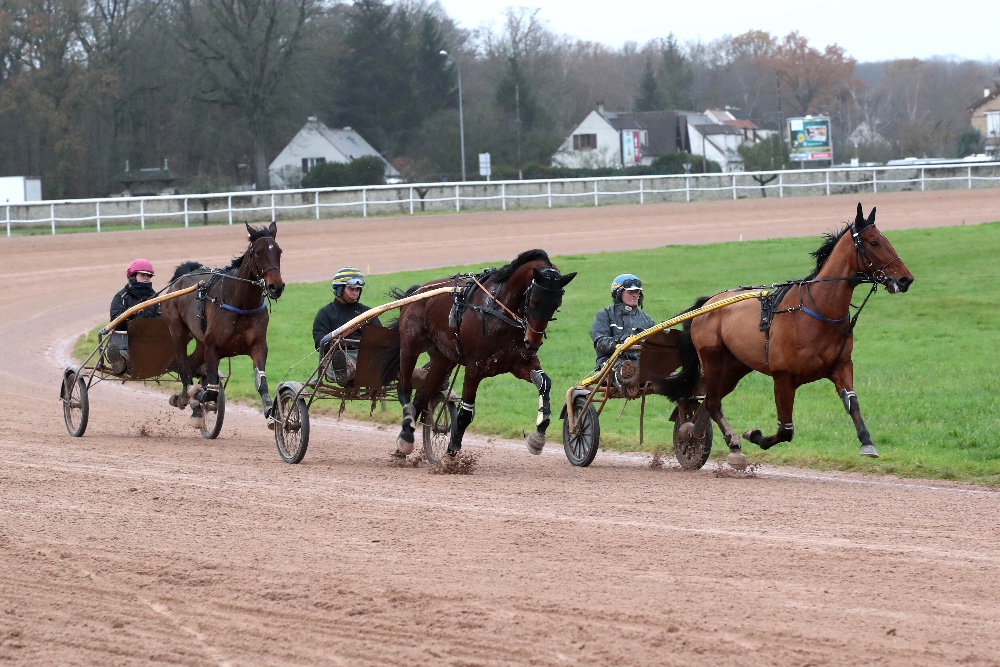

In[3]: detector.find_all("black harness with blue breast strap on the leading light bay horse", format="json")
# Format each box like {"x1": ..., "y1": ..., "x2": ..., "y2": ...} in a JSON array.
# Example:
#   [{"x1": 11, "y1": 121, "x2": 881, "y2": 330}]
[{"x1": 752, "y1": 224, "x2": 899, "y2": 365}]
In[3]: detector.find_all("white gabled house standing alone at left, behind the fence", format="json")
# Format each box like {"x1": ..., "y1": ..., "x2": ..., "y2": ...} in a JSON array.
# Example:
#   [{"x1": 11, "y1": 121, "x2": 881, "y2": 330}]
[{"x1": 268, "y1": 116, "x2": 399, "y2": 190}]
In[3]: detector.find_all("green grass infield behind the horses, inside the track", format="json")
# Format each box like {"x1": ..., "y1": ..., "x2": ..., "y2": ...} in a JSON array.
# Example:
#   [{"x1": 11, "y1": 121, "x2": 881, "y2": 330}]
[{"x1": 78, "y1": 223, "x2": 1000, "y2": 485}]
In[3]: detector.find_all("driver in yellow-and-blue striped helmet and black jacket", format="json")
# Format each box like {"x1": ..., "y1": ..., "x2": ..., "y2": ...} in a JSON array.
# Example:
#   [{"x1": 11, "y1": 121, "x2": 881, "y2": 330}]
[{"x1": 313, "y1": 266, "x2": 382, "y2": 385}]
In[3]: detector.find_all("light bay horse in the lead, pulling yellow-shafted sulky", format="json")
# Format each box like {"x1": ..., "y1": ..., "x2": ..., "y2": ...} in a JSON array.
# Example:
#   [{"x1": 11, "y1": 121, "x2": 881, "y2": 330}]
[{"x1": 658, "y1": 203, "x2": 913, "y2": 469}]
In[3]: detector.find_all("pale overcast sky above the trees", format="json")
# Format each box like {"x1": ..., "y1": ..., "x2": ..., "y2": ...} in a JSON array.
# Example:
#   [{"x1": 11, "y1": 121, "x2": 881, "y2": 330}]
[{"x1": 438, "y1": 0, "x2": 1000, "y2": 62}]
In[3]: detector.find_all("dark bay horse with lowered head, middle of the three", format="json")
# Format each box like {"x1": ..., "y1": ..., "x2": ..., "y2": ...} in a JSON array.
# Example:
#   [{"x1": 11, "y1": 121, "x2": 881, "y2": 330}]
[{"x1": 394, "y1": 249, "x2": 576, "y2": 457}]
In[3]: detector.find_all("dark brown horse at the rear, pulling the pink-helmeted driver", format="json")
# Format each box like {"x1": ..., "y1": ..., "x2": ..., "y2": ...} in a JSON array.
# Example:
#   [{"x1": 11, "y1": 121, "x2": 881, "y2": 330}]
[{"x1": 160, "y1": 222, "x2": 285, "y2": 428}]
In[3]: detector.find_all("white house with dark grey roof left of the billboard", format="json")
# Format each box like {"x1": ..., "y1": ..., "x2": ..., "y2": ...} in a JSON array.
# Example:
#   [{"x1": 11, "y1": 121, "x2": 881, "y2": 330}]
[{"x1": 552, "y1": 104, "x2": 682, "y2": 169}]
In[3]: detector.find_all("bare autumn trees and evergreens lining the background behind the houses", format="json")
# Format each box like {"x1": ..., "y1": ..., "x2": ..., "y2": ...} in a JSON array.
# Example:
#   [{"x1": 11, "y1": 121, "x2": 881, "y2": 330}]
[{"x1": 0, "y1": 0, "x2": 995, "y2": 198}]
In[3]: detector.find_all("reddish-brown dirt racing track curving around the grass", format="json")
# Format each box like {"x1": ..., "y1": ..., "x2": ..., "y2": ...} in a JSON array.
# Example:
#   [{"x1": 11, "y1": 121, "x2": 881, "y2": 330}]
[{"x1": 0, "y1": 190, "x2": 1000, "y2": 666}]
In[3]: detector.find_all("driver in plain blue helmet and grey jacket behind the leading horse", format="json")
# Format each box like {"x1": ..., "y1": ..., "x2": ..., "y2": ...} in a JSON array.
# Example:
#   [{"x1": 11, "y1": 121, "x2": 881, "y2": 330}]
[{"x1": 590, "y1": 273, "x2": 655, "y2": 384}]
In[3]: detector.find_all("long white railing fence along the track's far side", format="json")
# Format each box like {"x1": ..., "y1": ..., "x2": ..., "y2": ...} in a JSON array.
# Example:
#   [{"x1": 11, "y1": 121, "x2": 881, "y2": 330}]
[{"x1": 0, "y1": 162, "x2": 1000, "y2": 237}]
